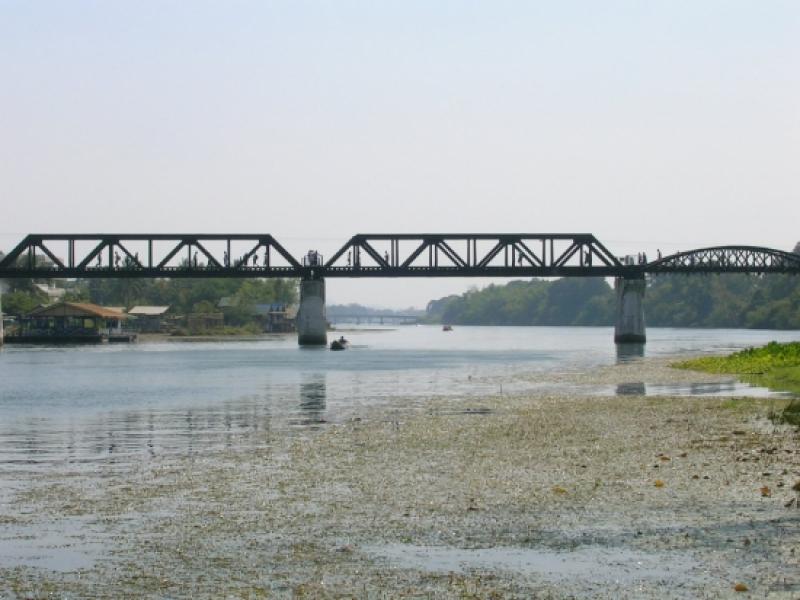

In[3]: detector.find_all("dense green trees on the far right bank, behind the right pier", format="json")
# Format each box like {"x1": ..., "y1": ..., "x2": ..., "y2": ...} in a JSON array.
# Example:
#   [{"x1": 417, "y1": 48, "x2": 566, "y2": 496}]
[{"x1": 426, "y1": 274, "x2": 800, "y2": 329}]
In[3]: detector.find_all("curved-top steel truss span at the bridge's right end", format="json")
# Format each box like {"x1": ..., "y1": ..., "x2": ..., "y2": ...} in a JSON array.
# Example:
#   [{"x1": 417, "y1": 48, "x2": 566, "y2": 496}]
[{"x1": 644, "y1": 246, "x2": 800, "y2": 274}]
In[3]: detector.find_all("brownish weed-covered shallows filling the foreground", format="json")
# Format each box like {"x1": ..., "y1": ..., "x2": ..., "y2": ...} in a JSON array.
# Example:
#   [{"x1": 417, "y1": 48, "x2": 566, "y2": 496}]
[{"x1": 0, "y1": 359, "x2": 800, "y2": 598}]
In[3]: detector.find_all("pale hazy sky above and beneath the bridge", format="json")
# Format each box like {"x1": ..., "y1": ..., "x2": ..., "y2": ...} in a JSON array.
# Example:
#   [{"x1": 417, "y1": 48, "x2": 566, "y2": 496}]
[{"x1": 0, "y1": 0, "x2": 800, "y2": 307}]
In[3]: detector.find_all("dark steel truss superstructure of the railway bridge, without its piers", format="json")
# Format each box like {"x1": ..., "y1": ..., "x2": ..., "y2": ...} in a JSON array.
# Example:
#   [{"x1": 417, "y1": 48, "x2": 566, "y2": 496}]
[{"x1": 0, "y1": 233, "x2": 800, "y2": 280}]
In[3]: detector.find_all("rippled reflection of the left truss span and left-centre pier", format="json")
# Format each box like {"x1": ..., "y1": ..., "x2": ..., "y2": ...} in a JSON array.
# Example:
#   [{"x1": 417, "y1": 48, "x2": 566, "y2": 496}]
[{"x1": 0, "y1": 373, "x2": 334, "y2": 473}]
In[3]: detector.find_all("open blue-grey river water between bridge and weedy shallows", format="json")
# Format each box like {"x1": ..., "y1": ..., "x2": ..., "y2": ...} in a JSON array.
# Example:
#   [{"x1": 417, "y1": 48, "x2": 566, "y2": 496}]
[{"x1": 0, "y1": 326, "x2": 800, "y2": 472}]
